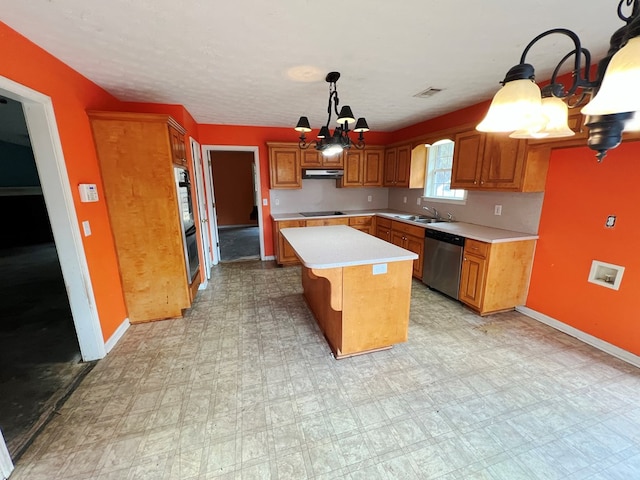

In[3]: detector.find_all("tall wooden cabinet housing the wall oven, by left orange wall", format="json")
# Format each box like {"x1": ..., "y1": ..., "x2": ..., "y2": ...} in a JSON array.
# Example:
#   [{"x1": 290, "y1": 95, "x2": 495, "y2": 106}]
[{"x1": 89, "y1": 112, "x2": 192, "y2": 323}]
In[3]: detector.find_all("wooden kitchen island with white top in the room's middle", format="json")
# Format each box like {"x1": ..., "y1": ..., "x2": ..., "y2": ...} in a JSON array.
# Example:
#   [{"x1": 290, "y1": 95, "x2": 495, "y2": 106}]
[{"x1": 281, "y1": 225, "x2": 417, "y2": 358}]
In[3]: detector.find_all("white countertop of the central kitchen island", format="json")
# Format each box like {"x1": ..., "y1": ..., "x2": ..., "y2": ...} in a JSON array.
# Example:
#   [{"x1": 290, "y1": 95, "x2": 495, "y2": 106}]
[{"x1": 280, "y1": 225, "x2": 418, "y2": 269}]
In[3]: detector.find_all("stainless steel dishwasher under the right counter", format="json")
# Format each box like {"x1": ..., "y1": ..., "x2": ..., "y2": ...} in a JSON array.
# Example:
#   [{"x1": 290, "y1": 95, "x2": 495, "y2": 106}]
[{"x1": 422, "y1": 228, "x2": 464, "y2": 300}]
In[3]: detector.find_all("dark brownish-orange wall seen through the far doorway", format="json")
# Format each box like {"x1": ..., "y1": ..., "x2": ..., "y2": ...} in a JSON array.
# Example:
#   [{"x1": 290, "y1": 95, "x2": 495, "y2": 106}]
[{"x1": 211, "y1": 151, "x2": 258, "y2": 226}]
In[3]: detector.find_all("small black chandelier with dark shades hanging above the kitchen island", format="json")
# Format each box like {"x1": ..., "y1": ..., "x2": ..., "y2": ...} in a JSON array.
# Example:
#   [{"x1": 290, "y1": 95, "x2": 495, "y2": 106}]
[{"x1": 295, "y1": 72, "x2": 369, "y2": 157}]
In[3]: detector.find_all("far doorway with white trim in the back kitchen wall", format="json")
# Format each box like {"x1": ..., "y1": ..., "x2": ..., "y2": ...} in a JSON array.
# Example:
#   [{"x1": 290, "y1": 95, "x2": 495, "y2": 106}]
[{"x1": 204, "y1": 147, "x2": 264, "y2": 262}]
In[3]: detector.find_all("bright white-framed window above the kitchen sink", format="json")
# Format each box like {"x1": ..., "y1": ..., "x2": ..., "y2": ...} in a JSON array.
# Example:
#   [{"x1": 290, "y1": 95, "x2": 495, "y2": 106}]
[{"x1": 424, "y1": 140, "x2": 467, "y2": 201}]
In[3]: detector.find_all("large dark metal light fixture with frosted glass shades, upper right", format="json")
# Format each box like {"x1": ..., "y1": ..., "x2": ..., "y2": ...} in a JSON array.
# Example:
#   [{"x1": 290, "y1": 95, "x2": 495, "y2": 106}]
[{"x1": 476, "y1": 0, "x2": 640, "y2": 162}]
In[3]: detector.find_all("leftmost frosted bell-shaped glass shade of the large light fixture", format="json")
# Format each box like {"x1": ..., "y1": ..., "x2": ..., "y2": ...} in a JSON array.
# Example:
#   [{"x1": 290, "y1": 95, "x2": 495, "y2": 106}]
[{"x1": 476, "y1": 79, "x2": 542, "y2": 132}]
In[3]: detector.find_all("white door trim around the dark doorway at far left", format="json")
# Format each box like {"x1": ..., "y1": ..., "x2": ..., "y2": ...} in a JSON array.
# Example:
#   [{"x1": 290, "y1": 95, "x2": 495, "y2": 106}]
[{"x1": 0, "y1": 76, "x2": 106, "y2": 361}]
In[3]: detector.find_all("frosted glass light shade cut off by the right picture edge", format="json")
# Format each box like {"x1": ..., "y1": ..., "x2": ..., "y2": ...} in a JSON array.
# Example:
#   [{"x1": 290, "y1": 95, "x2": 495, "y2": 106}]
[{"x1": 582, "y1": 37, "x2": 640, "y2": 115}]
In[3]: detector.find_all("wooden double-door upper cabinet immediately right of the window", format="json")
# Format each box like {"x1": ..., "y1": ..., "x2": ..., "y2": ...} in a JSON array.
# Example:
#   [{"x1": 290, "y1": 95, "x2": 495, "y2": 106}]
[{"x1": 451, "y1": 130, "x2": 549, "y2": 192}]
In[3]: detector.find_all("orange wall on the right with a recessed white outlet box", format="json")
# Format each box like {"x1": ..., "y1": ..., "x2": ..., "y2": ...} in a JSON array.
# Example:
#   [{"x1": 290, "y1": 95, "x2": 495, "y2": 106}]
[{"x1": 527, "y1": 142, "x2": 640, "y2": 355}]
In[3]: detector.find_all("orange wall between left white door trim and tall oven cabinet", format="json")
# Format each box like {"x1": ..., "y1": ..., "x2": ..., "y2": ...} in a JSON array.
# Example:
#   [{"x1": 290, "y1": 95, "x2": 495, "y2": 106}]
[{"x1": 0, "y1": 22, "x2": 127, "y2": 340}]
